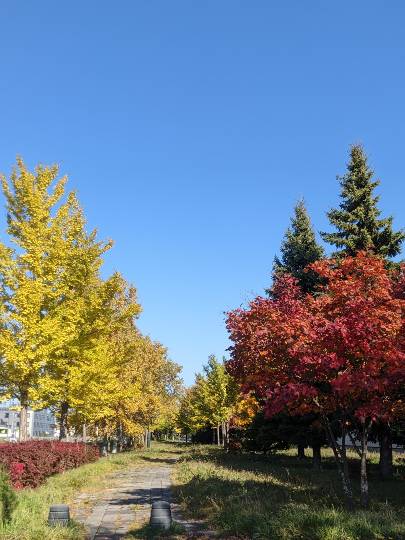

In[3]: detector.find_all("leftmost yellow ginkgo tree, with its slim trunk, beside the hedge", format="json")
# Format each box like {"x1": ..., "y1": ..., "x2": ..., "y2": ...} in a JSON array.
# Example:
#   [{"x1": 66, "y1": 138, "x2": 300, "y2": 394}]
[{"x1": 0, "y1": 159, "x2": 84, "y2": 440}]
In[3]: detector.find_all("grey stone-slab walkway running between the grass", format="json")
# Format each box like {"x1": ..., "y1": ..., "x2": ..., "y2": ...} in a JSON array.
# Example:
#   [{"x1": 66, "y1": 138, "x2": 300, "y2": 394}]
[{"x1": 72, "y1": 460, "x2": 212, "y2": 540}]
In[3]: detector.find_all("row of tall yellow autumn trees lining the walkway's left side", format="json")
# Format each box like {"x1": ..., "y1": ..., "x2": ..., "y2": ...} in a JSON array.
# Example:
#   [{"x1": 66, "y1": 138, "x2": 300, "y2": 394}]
[{"x1": 0, "y1": 159, "x2": 180, "y2": 443}]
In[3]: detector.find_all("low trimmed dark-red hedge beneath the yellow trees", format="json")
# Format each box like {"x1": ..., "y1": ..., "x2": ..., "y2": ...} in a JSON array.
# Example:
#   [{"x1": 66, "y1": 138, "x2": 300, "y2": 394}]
[{"x1": 0, "y1": 441, "x2": 100, "y2": 489}]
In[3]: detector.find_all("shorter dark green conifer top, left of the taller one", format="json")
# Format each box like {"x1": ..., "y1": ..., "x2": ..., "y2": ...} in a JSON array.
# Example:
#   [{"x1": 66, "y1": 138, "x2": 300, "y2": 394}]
[{"x1": 267, "y1": 200, "x2": 323, "y2": 293}]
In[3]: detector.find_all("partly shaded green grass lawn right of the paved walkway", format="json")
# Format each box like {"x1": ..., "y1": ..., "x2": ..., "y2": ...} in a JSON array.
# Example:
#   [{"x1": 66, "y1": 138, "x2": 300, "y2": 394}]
[{"x1": 175, "y1": 447, "x2": 405, "y2": 540}]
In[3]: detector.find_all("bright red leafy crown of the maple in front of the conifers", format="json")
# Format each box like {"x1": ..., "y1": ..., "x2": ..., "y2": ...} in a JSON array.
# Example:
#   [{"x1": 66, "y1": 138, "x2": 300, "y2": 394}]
[{"x1": 227, "y1": 253, "x2": 405, "y2": 426}]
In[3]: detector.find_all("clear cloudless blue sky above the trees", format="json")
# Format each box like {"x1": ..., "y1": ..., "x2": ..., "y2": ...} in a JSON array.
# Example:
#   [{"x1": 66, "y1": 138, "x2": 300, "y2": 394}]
[{"x1": 0, "y1": 0, "x2": 405, "y2": 383}]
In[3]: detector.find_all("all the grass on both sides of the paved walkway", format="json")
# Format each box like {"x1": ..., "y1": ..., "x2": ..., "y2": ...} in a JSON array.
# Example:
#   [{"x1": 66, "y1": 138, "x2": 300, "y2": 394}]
[{"x1": 0, "y1": 443, "x2": 405, "y2": 540}]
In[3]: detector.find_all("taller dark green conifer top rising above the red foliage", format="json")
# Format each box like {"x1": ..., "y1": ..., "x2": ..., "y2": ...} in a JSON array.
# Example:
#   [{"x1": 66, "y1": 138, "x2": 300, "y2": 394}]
[{"x1": 321, "y1": 145, "x2": 405, "y2": 257}]
